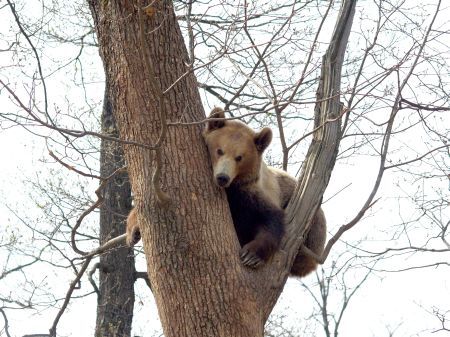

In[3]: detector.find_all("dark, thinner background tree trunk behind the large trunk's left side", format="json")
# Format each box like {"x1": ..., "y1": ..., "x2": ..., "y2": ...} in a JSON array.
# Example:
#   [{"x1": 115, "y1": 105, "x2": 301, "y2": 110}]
[{"x1": 95, "y1": 84, "x2": 134, "y2": 337}]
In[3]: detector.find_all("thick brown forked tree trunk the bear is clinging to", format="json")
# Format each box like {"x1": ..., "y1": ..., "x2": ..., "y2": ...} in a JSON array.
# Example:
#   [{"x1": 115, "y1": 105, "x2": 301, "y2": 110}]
[{"x1": 89, "y1": 0, "x2": 351, "y2": 337}]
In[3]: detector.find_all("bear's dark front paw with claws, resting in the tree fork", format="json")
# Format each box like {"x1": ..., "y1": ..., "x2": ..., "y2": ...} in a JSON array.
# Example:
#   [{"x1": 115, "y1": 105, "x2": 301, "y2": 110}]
[{"x1": 239, "y1": 229, "x2": 280, "y2": 268}]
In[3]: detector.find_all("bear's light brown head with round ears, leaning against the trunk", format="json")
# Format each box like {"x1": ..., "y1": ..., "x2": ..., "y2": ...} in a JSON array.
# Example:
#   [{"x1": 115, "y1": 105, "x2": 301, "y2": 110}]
[{"x1": 203, "y1": 108, "x2": 272, "y2": 188}]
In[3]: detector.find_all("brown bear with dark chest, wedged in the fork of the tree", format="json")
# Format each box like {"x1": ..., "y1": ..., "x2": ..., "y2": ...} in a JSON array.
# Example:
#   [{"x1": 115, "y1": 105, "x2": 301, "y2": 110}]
[{"x1": 203, "y1": 108, "x2": 326, "y2": 277}]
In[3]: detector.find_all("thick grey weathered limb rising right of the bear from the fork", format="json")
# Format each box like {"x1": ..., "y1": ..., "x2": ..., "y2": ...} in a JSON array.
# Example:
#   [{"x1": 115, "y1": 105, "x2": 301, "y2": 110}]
[{"x1": 263, "y1": 0, "x2": 356, "y2": 317}]
